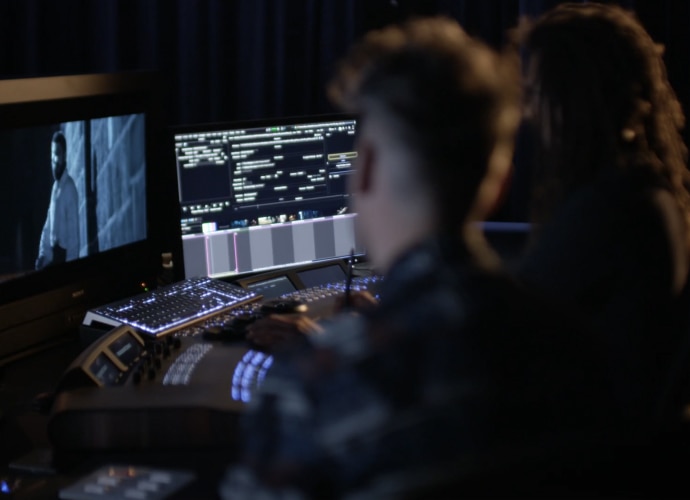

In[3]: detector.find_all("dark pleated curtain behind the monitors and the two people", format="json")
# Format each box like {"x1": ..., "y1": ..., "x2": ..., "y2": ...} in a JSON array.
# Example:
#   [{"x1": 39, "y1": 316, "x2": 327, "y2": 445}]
[{"x1": 0, "y1": 0, "x2": 690, "y2": 219}]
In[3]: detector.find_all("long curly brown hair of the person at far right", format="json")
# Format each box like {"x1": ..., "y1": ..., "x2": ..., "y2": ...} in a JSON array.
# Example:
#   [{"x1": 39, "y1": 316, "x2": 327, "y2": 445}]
[{"x1": 512, "y1": 2, "x2": 690, "y2": 244}]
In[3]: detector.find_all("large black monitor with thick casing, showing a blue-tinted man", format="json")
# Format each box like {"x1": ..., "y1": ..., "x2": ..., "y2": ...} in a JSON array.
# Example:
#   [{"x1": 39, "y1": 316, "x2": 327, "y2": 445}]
[{"x1": 0, "y1": 73, "x2": 179, "y2": 364}]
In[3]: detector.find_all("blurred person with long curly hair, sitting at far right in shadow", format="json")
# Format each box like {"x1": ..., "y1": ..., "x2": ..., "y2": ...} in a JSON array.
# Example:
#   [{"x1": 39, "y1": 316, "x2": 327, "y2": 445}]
[{"x1": 515, "y1": 2, "x2": 690, "y2": 424}]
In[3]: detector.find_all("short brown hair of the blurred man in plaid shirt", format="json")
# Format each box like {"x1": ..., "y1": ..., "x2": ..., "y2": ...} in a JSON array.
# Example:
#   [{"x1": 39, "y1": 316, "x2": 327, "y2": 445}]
[{"x1": 328, "y1": 17, "x2": 520, "y2": 225}]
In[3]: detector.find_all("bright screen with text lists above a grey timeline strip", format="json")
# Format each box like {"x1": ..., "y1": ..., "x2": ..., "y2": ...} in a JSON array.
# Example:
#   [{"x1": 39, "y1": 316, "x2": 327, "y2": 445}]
[{"x1": 173, "y1": 115, "x2": 364, "y2": 279}]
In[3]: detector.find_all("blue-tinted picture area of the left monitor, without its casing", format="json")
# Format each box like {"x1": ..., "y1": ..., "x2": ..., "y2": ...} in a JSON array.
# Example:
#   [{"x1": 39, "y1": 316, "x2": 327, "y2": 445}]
[{"x1": 7, "y1": 113, "x2": 147, "y2": 274}]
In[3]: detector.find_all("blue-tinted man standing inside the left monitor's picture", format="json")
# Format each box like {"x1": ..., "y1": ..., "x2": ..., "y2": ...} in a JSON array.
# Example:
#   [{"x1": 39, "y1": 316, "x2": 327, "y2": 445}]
[{"x1": 36, "y1": 131, "x2": 79, "y2": 269}]
